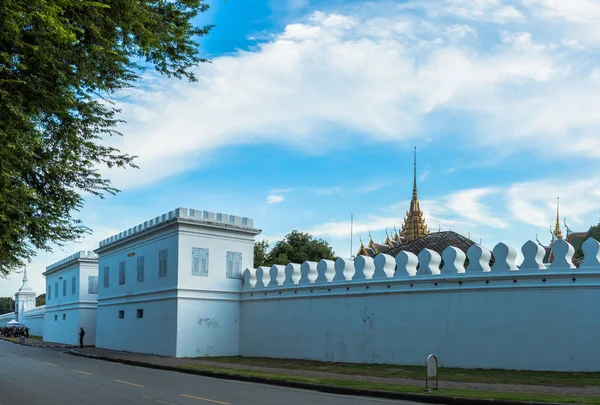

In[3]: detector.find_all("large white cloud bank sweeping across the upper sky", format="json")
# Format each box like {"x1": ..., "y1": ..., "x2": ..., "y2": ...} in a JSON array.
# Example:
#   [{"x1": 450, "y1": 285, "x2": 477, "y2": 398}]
[{"x1": 94, "y1": 0, "x2": 600, "y2": 188}]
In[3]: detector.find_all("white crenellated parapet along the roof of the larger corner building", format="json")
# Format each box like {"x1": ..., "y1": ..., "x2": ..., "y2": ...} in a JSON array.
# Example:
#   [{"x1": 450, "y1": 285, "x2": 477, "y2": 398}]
[{"x1": 99, "y1": 208, "x2": 254, "y2": 248}]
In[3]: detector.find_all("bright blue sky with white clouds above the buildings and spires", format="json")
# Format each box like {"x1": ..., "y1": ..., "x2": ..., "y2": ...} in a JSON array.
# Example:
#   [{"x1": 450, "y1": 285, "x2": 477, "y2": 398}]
[{"x1": 0, "y1": 0, "x2": 600, "y2": 296}]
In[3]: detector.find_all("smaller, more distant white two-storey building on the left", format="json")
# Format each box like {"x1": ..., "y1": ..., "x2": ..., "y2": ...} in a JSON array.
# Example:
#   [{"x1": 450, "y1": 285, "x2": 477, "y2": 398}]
[{"x1": 43, "y1": 251, "x2": 98, "y2": 345}]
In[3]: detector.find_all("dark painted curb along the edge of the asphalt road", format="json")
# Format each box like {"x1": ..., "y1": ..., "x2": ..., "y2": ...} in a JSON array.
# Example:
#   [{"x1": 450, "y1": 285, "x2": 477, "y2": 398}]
[{"x1": 68, "y1": 349, "x2": 565, "y2": 405}]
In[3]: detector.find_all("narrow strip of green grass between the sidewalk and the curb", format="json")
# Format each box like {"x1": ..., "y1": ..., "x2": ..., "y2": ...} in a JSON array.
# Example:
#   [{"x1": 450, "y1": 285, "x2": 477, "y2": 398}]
[{"x1": 183, "y1": 365, "x2": 600, "y2": 405}]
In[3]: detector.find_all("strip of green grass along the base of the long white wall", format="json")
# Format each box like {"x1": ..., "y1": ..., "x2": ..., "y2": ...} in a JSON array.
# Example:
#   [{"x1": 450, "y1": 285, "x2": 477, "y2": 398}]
[{"x1": 202, "y1": 357, "x2": 600, "y2": 387}]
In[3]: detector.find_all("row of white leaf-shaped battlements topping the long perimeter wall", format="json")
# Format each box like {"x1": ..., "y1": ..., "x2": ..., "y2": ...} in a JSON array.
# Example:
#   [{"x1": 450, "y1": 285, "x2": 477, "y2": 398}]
[{"x1": 242, "y1": 238, "x2": 600, "y2": 298}]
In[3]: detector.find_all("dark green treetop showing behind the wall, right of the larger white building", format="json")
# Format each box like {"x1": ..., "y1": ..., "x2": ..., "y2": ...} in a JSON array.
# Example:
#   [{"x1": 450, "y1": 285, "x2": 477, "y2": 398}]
[{"x1": 254, "y1": 230, "x2": 335, "y2": 267}]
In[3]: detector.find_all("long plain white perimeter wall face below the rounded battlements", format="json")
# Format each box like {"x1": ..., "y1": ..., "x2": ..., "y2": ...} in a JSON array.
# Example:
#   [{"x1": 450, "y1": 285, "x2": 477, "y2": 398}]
[{"x1": 240, "y1": 269, "x2": 600, "y2": 371}]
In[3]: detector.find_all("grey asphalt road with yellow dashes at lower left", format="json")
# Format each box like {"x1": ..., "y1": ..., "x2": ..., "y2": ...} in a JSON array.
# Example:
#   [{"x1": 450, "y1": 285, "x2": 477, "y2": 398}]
[{"x1": 0, "y1": 340, "x2": 424, "y2": 405}]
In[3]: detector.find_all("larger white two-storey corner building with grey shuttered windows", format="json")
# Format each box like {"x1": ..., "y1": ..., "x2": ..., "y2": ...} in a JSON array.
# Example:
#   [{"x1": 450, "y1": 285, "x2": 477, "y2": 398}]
[{"x1": 96, "y1": 208, "x2": 260, "y2": 357}]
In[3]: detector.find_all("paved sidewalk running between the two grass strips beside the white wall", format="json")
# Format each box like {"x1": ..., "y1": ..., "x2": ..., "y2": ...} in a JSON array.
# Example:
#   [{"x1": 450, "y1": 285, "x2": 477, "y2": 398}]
[{"x1": 71, "y1": 347, "x2": 600, "y2": 396}]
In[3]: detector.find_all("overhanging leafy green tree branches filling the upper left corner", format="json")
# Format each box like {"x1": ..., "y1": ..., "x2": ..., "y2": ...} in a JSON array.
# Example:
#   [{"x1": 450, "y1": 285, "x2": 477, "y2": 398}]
[{"x1": 0, "y1": 0, "x2": 211, "y2": 276}]
